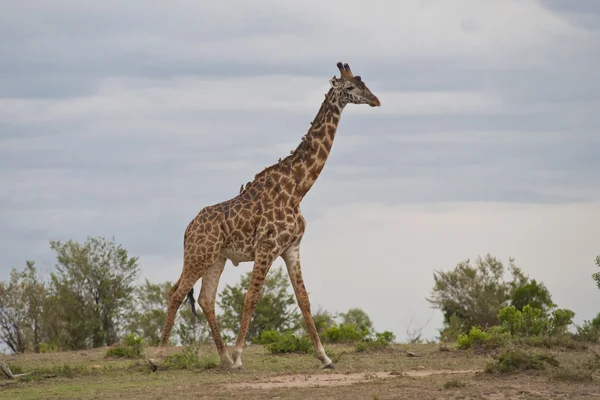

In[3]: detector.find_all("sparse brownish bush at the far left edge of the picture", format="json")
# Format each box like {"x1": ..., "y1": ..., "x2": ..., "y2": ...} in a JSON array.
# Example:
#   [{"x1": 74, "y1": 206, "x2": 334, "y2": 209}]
[{"x1": 0, "y1": 261, "x2": 46, "y2": 353}]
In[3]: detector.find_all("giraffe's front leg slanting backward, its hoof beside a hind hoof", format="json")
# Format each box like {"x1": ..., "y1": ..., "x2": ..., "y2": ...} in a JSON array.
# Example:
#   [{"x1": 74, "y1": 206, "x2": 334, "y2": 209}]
[{"x1": 232, "y1": 251, "x2": 275, "y2": 369}]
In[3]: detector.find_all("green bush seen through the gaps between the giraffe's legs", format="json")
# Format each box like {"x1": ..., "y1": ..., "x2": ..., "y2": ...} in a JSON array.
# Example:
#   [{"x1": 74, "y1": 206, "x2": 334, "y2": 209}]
[{"x1": 218, "y1": 267, "x2": 301, "y2": 340}]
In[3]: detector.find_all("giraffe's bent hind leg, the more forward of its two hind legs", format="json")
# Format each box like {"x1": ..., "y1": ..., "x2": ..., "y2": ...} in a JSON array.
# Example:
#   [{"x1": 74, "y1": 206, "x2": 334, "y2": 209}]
[{"x1": 198, "y1": 257, "x2": 233, "y2": 367}]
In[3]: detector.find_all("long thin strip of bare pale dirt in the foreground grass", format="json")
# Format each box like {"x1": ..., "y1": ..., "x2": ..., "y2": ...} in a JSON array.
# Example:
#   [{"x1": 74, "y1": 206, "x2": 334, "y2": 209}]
[{"x1": 226, "y1": 369, "x2": 479, "y2": 389}]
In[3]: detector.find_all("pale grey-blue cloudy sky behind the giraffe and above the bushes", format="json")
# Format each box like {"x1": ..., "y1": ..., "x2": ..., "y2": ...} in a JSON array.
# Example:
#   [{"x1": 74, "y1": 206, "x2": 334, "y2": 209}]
[{"x1": 0, "y1": 0, "x2": 600, "y2": 339}]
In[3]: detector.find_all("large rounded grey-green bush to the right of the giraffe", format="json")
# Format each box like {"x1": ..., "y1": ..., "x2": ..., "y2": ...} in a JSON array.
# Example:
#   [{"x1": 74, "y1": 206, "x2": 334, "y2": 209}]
[{"x1": 427, "y1": 254, "x2": 554, "y2": 339}]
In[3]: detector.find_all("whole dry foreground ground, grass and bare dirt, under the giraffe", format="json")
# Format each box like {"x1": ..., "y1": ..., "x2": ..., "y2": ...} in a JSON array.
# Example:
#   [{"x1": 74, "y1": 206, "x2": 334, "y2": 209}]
[{"x1": 0, "y1": 345, "x2": 600, "y2": 400}]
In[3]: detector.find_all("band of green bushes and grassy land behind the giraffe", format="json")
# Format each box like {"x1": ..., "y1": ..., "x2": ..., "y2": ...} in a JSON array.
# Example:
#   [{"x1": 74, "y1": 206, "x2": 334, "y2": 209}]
[{"x1": 0, "y1": 237, "x2": 600, "y2": 398}]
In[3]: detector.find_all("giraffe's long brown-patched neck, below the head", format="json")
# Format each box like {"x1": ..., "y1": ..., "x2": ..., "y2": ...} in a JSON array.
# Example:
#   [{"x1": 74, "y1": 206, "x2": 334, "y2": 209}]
[{"x1": 284, "y1": 88, "x2": 347, "y2": 203}]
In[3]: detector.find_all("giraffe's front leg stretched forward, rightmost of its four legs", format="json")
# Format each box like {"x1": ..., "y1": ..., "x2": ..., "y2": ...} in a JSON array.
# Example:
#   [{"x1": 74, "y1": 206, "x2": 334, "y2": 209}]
[{"x1": 281, "y1": 247, "x2": 335, "y2": 369}]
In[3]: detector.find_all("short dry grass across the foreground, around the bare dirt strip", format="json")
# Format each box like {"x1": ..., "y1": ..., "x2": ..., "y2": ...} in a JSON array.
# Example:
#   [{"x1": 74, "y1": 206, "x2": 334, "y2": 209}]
[{"x1": 0, "y1": 344, "x2": 600, "y2": 400}]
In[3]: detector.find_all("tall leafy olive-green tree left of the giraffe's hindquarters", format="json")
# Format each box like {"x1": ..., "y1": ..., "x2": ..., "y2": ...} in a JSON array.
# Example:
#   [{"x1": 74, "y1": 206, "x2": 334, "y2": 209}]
[{"x1": 50, "y1": 237, "x2": 139, "y2": 349}]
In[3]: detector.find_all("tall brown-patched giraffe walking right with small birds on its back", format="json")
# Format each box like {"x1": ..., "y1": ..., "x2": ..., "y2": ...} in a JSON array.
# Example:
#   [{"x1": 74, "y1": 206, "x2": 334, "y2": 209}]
[{"x1": 155, "y1": 62, "x2": 381, "y2": 369}]
